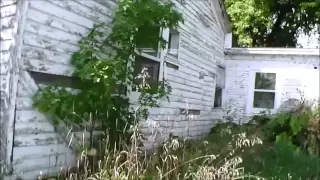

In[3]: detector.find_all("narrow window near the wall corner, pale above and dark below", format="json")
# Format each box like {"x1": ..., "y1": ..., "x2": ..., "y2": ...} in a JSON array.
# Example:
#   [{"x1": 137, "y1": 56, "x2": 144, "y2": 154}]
[{"x1": 213, "y1": 66, "x2": 225, "y2": 108}]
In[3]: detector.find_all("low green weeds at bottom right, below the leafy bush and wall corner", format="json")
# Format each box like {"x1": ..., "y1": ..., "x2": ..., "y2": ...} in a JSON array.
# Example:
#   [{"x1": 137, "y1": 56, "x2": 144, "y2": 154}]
[{"x1": 209, "y1": 120, "x2": 320, "y2": 180}]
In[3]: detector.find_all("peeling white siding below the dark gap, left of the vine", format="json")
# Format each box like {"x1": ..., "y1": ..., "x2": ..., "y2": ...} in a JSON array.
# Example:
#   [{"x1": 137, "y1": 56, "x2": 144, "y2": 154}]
[{"x1": 8, "y1": 71, "x2": 75, "y2": 179}]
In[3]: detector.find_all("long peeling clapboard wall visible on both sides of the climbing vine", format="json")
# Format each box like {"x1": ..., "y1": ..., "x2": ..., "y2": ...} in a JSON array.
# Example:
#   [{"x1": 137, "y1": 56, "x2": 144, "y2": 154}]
[{"x1": 1, "y1": 0, "x2": 225, "y2": 179}]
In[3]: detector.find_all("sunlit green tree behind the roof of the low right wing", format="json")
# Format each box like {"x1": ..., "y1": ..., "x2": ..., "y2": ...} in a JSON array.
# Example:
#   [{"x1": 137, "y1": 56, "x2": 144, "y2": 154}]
[{"x1": 224, "y1": 0, "x2": 320, "y2": 47}]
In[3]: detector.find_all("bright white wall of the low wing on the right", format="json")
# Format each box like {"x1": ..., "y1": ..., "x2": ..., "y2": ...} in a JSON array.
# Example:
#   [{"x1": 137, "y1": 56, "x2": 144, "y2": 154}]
[{"x1": 223, "y1": 48, "x2": 320, "y2": 123}]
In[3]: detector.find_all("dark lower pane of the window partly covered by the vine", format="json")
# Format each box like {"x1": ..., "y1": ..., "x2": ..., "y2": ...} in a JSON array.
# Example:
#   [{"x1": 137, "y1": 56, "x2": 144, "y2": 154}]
[{"x1": 134, "y1": 56, "x2": 160, "y2": 89}]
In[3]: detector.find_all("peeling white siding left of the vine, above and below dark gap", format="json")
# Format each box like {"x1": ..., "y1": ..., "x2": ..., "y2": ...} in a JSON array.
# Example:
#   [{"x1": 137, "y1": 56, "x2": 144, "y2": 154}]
[{"x1": 2, "y1": 1, "x2": 116, "y2": 179}]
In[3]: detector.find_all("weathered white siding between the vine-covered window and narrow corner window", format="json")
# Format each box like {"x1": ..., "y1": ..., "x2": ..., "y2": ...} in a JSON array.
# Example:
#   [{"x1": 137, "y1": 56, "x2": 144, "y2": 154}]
[{"x1": 150, "y1": 1, "x2": 224, "y2": 137}]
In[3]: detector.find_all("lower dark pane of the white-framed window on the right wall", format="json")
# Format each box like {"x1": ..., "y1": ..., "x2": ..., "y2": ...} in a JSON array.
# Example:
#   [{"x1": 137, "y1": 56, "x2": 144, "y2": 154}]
[{"x1": 253, "y1": 91, "x2": 275, "y2": 109}]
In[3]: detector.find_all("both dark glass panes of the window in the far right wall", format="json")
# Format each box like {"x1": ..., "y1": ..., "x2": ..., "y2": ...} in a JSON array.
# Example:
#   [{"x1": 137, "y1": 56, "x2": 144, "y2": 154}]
[{"x1": 253, "y1": 73, "x2": 276, "y2": 109}]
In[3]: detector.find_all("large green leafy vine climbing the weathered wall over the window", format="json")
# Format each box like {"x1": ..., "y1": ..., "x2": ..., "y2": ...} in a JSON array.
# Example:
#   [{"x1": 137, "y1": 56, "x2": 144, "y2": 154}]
[{"x1": 34, "y1": 0, "x2": 183, "y2": 147}]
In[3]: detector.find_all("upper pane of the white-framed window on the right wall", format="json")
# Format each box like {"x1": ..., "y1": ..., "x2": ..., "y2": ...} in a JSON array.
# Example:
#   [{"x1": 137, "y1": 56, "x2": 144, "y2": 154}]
[{"x1": 254, "y1": 73, "x2": 276, "y2": 90}]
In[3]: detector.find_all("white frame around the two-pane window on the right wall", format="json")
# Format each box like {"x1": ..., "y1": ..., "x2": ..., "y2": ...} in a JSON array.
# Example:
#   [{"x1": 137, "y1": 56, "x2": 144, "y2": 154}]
[{"x1": 246, "y1": 70, "x2": 282, "y2": 115}]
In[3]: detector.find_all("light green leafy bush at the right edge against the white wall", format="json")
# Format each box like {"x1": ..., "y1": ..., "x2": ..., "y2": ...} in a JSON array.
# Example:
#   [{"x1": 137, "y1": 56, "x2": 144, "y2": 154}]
[{"x1": 263, "y1": 102, "x2": 320, "y2": 156}]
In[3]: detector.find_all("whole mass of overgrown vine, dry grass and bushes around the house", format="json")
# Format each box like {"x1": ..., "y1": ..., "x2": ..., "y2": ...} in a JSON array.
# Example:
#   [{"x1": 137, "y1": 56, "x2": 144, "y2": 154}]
[{"x1": 30, "y1": 0, "x2": 320, "y2": 180}]
